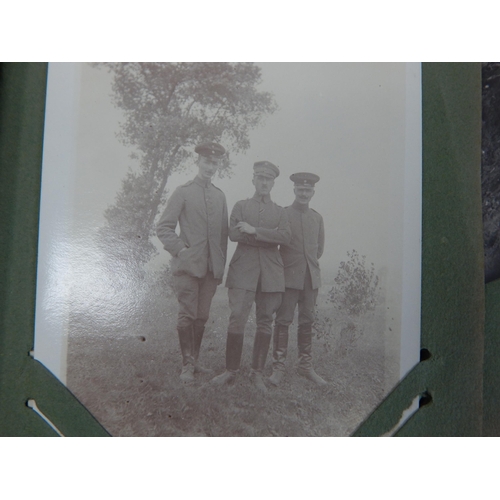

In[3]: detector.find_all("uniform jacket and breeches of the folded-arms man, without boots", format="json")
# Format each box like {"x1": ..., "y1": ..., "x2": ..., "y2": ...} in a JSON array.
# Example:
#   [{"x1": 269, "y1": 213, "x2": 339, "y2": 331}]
[{"x1": 226, "y1": 195, "x2": 290, "y2": 335}]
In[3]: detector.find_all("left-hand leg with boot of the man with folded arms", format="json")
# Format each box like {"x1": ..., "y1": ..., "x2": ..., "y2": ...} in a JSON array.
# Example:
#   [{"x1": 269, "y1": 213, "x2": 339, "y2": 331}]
[{"x1": 212, "y1": 288, "x2": 255, "y2": 385}]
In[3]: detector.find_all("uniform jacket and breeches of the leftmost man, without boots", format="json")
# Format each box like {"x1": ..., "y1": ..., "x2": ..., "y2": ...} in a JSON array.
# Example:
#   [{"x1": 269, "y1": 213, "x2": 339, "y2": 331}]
[{"x1": 156, "y1": 177, "x2": 228, "y2": 328}]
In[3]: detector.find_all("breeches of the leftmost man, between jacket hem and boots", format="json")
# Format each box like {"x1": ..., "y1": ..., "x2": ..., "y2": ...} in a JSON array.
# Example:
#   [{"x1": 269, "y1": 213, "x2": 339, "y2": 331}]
[{"x1": 173, "y1": 272, "x2": 221, "y2": 328}]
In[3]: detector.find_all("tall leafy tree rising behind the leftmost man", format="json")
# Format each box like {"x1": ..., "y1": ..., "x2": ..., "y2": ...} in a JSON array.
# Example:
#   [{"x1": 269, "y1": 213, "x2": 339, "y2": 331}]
[{"x1": 93, "y1": 63, "x2": 277, "y2": 276}]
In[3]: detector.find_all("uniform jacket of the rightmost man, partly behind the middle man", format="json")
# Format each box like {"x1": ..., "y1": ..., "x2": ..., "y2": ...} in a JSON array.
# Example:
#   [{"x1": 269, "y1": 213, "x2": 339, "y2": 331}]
[{"x1": 280, "y1": 202, "x2": 325, "y2": 290}]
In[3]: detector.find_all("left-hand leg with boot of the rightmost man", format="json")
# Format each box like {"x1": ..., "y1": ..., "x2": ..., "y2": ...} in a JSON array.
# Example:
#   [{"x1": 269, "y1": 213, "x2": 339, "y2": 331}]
[{"x1": 269, "y1": 288, "x2": 300, "y2": 385}]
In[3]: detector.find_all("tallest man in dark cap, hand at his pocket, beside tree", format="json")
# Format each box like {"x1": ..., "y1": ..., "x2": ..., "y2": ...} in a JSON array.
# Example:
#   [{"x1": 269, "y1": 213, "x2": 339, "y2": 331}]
[{"x1": 156, "y1": 143, "x2": 228, "y2": 383}]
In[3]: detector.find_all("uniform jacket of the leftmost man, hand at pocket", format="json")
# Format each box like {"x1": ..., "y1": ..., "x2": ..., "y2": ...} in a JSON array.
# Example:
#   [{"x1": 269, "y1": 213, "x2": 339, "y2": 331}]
[{"x1": 156, "y1": 177, "x2": 228, "y2": 280}]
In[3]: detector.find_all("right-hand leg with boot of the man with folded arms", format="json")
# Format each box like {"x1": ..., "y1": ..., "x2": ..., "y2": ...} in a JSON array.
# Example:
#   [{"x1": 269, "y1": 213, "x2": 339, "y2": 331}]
[{"x1": 251, "y1": 289, "x2": 283, "y2": 391}]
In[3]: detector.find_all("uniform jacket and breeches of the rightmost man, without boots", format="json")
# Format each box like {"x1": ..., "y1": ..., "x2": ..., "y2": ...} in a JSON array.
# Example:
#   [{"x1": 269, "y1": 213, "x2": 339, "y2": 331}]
[{"x1": 276, "y1": 202, "x2": 325, "y2": 331}]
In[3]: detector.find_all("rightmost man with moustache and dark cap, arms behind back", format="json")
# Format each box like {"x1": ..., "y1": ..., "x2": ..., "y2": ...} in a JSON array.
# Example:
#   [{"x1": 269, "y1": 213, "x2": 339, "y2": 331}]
[{"x1": 269, "y1": 172, "x2": 327, "y2": 386}]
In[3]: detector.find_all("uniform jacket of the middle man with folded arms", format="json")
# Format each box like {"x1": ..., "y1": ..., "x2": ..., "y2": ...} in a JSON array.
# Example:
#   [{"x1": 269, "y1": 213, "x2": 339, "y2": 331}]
[{"x1": 226, "y1": 195, "x2": 290, "y2": 292}]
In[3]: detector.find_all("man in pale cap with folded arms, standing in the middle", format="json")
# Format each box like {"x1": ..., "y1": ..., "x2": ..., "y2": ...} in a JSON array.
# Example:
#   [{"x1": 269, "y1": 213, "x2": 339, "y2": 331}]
[{"x1": 213, "y1": 161, "x2": 290, "y2": 391}]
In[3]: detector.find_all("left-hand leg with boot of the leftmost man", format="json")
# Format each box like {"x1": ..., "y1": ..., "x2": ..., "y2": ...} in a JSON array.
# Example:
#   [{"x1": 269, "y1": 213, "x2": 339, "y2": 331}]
[{"x1": 174, "y1": 273, "x2": 198, "y2": 382}]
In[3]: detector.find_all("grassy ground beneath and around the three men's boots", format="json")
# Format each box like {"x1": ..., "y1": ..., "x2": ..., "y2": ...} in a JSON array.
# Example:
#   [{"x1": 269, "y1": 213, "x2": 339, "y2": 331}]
[{"x1": 68, "y1": 286, "x2": 398, "y2": 436}]
